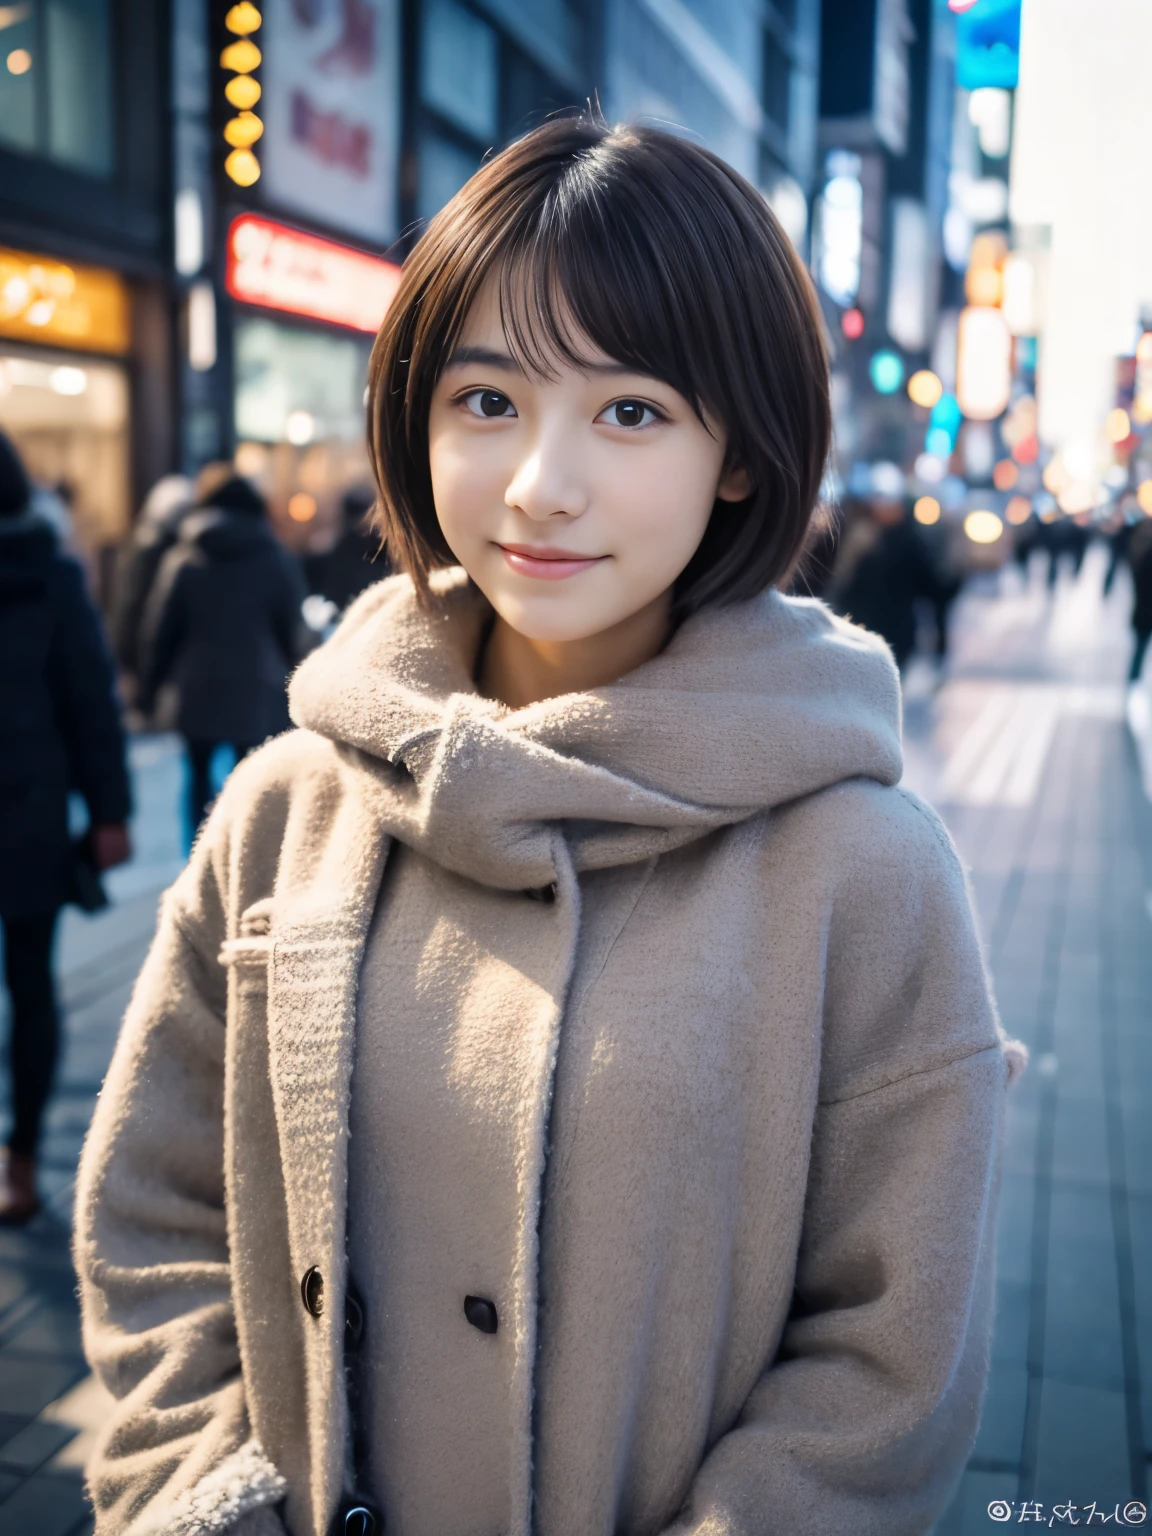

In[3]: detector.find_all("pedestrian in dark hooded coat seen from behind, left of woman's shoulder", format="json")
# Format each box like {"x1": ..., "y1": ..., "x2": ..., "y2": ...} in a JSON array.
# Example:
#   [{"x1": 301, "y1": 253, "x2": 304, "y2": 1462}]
[{"x1": 140, "y1": 476, "x2": 306, "y2": 833}]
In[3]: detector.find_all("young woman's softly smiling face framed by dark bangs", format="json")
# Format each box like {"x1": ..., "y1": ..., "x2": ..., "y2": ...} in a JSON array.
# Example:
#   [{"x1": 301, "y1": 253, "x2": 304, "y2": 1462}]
[{"x1": 429, "y1": 281, "x2": 748, "y2": 642}]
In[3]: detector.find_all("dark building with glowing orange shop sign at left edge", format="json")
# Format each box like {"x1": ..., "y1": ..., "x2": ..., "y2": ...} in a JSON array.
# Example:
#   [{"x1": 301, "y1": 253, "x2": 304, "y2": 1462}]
[{"x1": 0, "y1": 0, "x2": 175, "y2": 589}]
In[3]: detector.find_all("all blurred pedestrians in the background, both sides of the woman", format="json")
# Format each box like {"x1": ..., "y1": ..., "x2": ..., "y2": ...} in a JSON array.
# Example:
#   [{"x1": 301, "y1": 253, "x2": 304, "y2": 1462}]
[{"x1": 0, "y1": 411, "x2": 1152, "y2": 1223}]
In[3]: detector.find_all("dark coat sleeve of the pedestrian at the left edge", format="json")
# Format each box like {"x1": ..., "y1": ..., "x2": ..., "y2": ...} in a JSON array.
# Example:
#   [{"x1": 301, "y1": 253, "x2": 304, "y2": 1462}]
[{"x1": 49, "y1": 558, "x2": 132, "y2": 825}]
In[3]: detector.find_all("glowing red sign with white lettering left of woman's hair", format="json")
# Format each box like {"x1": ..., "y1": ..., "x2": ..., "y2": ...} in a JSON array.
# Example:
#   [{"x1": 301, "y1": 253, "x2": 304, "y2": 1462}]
[{"x1": 224, "y1": 214, "x2": 401, "y2": 332}]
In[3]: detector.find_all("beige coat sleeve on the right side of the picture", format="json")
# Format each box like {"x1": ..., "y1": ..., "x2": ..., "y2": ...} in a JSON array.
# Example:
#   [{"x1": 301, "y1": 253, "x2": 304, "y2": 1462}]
[{"x1": 665, "y1": 808, "x2": 1023, "y2": 1536}]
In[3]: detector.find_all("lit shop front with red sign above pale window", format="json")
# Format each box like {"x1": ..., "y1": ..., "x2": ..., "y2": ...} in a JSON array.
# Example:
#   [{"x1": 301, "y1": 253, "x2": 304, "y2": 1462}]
[{"x1": 226, "y1": 214, "x2": 399, "y2": 548}]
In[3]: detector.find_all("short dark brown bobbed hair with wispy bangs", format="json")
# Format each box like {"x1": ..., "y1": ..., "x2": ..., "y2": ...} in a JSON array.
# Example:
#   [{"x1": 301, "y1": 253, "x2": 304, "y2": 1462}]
[{"x1": 369, "y1": 114, "x2": 831, "y2": 614}]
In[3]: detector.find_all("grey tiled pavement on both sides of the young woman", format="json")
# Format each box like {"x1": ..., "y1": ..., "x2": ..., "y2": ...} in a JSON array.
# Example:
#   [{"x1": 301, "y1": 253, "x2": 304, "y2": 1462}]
[{"x1": 0, "y1": 553, "x2": 1152, "y2": 1536}]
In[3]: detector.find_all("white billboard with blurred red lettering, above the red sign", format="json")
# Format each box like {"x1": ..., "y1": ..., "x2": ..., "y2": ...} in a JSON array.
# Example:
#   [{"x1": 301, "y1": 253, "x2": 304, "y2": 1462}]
[{"x1": 257, "y1": 0, "x2": 399, "y2": 244}]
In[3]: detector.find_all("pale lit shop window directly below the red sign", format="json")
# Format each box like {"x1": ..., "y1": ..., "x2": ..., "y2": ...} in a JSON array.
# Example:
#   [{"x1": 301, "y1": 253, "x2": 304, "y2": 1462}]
[{"x1": 237, "y1": 319, "x2": 372, "y2": 447}]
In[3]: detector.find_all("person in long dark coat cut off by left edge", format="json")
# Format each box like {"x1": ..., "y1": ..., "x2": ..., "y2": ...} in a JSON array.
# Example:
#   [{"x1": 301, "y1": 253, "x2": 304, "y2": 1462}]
[{"x1": 0, "y1": 433, "x2": 131, "y2": 1223}]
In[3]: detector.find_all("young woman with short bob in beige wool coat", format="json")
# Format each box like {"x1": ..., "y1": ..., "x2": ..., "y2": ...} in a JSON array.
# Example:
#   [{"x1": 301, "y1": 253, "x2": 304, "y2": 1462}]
[{"x1": 77, "y1": 118, "x2": 1008, "y2": 1536}]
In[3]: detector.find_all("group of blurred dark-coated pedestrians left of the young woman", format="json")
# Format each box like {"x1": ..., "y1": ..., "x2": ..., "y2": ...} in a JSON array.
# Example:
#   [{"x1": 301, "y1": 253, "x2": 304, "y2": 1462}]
[{"x1": 0, "y1": 433, "x2": 387, "y2": 1224}]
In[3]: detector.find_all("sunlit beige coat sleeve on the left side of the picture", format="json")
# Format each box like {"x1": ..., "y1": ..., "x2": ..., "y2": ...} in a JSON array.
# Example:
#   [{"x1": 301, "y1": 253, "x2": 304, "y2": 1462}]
[{"x1": 75, "y1": 805, "x2": 286, "y2": 1536}]
